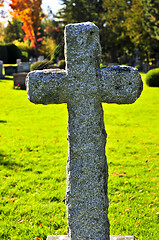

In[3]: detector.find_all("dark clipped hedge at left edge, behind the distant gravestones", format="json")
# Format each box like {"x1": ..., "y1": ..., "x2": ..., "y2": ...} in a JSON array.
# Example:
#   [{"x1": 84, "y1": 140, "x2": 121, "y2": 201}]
[{"x1": 0, "y1": 43, "x2": 22, "y2": 64}]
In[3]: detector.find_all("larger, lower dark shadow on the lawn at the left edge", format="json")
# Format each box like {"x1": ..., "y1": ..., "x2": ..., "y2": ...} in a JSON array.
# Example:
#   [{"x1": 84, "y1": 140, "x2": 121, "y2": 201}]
[{"x1": 0, "y1": 152, "x2": 23, "y2": 170}]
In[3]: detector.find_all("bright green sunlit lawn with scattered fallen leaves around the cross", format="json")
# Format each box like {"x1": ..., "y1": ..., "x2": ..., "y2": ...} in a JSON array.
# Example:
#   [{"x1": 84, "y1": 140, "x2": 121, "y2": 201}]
[{"x1": 0, "y1": 74, "x2": 159, "y2": 240}]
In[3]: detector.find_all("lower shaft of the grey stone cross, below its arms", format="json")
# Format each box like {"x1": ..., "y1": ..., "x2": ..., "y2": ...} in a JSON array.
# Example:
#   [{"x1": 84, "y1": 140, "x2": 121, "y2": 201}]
[{"x1": 67, "y1": 101, "x2": 109, "y2": 240}]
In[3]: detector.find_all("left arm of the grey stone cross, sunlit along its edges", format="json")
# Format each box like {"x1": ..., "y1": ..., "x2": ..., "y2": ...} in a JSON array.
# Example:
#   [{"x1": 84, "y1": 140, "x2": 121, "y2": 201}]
[{"x1": 26, "y1": 69, "x2": 67, "y2": 104}]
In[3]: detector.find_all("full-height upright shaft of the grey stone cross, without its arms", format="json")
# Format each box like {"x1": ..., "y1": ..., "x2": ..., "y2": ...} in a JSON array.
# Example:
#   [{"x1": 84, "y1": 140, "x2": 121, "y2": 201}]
[{"x1": 65, "y1": 24, "x2": 109, "y2": 240}]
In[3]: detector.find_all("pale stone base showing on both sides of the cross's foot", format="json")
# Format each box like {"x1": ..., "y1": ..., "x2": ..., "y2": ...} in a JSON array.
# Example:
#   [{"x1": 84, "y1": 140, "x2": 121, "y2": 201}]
[{"x1": 46, "y1": 235, "x2": 134, "y2": 240}]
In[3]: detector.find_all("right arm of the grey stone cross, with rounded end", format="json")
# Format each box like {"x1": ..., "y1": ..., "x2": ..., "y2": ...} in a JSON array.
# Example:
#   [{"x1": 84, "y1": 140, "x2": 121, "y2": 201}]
[{"x1": 99, "y1": 66, "x2": 143, "y2": 104}]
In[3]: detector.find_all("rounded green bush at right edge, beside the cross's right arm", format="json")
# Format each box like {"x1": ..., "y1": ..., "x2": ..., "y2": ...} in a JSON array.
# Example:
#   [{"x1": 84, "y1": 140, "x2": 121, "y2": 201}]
[{"x1": 146, "y1": 68, "x2": 159, "y2": 87}]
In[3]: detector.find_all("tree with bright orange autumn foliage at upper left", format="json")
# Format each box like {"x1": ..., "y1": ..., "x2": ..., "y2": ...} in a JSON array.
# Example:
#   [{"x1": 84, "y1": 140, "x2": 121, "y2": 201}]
[{"x1": 9, "y1": 0, "x2": 45, "y2": 52}]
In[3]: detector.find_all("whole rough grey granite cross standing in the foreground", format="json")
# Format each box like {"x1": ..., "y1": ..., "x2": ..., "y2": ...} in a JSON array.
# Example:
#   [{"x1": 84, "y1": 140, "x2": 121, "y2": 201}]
[{"x1": 27, "y1": 22, "x2": 142, "y2": 240}]
